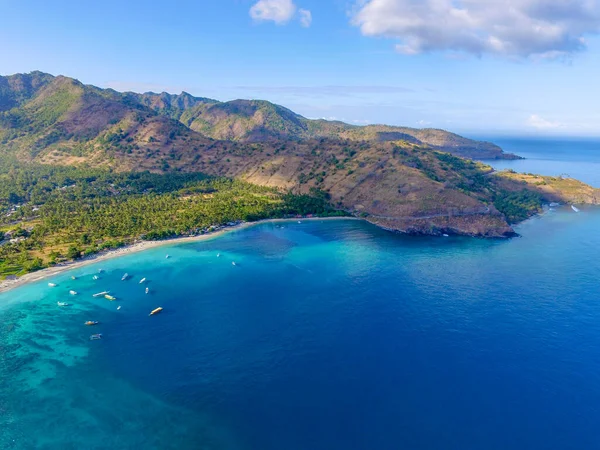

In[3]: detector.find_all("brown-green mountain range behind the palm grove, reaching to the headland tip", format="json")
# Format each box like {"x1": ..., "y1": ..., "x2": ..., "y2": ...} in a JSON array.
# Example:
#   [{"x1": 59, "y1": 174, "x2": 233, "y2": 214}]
[{"x1": 0, "y1": 72, "x2": 600, "y2": 251}]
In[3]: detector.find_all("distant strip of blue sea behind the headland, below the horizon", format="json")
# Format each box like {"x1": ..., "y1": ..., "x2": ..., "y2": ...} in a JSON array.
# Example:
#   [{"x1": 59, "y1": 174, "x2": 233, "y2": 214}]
[{"x1": 486, "y1": 137, "x2": 600, "y2": 188}]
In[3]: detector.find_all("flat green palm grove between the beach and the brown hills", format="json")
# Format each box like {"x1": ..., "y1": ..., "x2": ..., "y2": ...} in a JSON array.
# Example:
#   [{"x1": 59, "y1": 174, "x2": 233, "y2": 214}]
[{"x1": 0, "y1": 161, "x2": 340, "y2": 277}]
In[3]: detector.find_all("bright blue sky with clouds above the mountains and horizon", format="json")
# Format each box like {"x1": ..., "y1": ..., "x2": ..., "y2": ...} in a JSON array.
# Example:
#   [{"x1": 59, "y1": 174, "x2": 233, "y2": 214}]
[{"x1": 0, "y1": 0, "x2": 600, "y2": 136}]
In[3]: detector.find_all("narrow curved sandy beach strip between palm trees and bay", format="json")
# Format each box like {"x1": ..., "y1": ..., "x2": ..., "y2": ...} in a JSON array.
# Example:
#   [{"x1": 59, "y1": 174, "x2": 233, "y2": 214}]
[{"x1": 0, "y1": 216, "x2": 361, "y2": 294}]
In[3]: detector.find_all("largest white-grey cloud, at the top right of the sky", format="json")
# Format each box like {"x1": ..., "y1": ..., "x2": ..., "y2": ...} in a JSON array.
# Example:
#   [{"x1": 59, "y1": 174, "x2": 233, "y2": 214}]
[{"x1": 352, "y1": 0, "x2": 600, "y2": 58}]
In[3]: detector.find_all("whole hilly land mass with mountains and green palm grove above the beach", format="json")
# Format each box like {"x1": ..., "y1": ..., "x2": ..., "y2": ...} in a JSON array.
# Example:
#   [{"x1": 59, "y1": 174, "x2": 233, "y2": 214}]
[{"x1": 0, "y1": 72, "x2": 600, "y2": 276}]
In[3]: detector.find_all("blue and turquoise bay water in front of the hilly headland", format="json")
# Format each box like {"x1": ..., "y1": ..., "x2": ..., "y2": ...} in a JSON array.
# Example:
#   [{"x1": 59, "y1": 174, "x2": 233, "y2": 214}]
[{"x1": 0, "y1": 139, "x2": 600, "y2": 450}]
